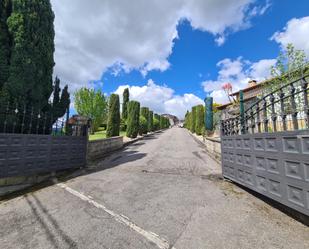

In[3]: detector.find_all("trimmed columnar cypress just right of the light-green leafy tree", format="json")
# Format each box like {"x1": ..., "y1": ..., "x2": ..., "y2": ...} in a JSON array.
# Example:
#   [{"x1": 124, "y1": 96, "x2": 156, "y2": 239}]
[{"x1": 106, "y1": 94, "x2": 120, "y2": 137}]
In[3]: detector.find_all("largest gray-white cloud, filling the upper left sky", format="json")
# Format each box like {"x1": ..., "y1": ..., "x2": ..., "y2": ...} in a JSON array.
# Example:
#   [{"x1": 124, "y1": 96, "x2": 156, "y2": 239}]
[{"x1": 51, "y1": 0, "x2": 263, "y2": 89}]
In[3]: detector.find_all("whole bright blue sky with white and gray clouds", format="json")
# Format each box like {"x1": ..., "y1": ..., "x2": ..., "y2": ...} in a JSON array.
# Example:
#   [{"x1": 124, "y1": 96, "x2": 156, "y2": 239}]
[{"x1": 51, "y1": 0, "x2": 309, "y2": 118}]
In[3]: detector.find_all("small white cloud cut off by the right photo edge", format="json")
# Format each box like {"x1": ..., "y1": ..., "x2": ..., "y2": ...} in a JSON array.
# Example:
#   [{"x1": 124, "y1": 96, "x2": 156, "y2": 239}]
[{"x1": 271, "y1": 16, "x2": 309, "y2": 56}]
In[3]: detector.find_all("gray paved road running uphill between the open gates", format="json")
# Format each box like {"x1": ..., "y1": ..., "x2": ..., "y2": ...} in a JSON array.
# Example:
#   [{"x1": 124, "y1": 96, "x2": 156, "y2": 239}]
[{"x1": 0, "y1": 128, "x2": 309, "y2": 249}]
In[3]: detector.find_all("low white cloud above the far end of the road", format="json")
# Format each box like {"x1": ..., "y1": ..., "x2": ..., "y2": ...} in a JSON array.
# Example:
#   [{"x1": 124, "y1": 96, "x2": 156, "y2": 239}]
[{"x1": 115, "y1": 80, "x2": 204, "y2": 118}]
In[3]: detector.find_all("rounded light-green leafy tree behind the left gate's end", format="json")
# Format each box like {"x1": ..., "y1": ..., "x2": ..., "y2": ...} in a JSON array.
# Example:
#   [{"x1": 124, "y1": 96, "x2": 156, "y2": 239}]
[{"x1": 74, "y1": 88, "x2": 107, "y2": 133}]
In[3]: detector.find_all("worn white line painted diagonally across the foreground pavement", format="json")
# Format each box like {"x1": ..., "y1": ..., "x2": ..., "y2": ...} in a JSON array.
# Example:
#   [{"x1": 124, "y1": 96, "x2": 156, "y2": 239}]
[{"x1": 57, "y1": 183, "x2": 176, "y2": 249}]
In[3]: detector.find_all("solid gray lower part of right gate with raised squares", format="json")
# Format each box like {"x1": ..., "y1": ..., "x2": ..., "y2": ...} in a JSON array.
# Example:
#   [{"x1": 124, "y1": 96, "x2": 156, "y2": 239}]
[{"x1": 221, "y1": 131, "x2": 309, "y2": 215}]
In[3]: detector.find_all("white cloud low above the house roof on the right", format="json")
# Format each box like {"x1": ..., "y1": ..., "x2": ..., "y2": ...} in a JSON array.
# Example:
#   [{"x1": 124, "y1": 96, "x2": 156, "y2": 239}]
[{"x1": 202, "y1": 57, "x2": 276, "y2": 104}]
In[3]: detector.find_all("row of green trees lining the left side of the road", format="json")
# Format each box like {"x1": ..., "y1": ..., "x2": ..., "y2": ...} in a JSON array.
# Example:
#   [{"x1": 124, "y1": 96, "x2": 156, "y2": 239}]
[{"x1": 74, "y1": 88, "x2": 170, "y2": 138}]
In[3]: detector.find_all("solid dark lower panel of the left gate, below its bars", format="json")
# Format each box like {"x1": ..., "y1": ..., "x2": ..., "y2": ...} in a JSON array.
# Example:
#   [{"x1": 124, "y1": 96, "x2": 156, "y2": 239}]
[{"x1": 0, "y1": 134, "x2": 88, "y2": 178}]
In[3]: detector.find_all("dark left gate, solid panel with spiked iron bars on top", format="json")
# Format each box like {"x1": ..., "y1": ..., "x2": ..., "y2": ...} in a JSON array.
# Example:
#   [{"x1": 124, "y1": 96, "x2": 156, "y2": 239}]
[{"x1": 0, "y1": 103, "x2": 89, "y2": 178}]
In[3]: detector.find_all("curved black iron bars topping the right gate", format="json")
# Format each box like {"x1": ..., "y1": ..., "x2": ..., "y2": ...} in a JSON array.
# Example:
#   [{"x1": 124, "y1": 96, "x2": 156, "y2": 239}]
[{"x1": 221, "y1": 75, "x2": 309, "y2": 136}]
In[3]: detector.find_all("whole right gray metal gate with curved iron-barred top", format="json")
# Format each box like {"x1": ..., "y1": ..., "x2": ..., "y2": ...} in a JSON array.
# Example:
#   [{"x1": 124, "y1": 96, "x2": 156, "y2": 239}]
[{"x1": 221, "y1": 72, "x2": 309, "y2": 215}]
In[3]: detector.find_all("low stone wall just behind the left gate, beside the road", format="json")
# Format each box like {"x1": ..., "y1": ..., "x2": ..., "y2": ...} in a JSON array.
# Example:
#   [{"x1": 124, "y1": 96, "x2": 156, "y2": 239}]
[{"x1": 87, "y1": 137, "x2": 123, "y2": 160}]
